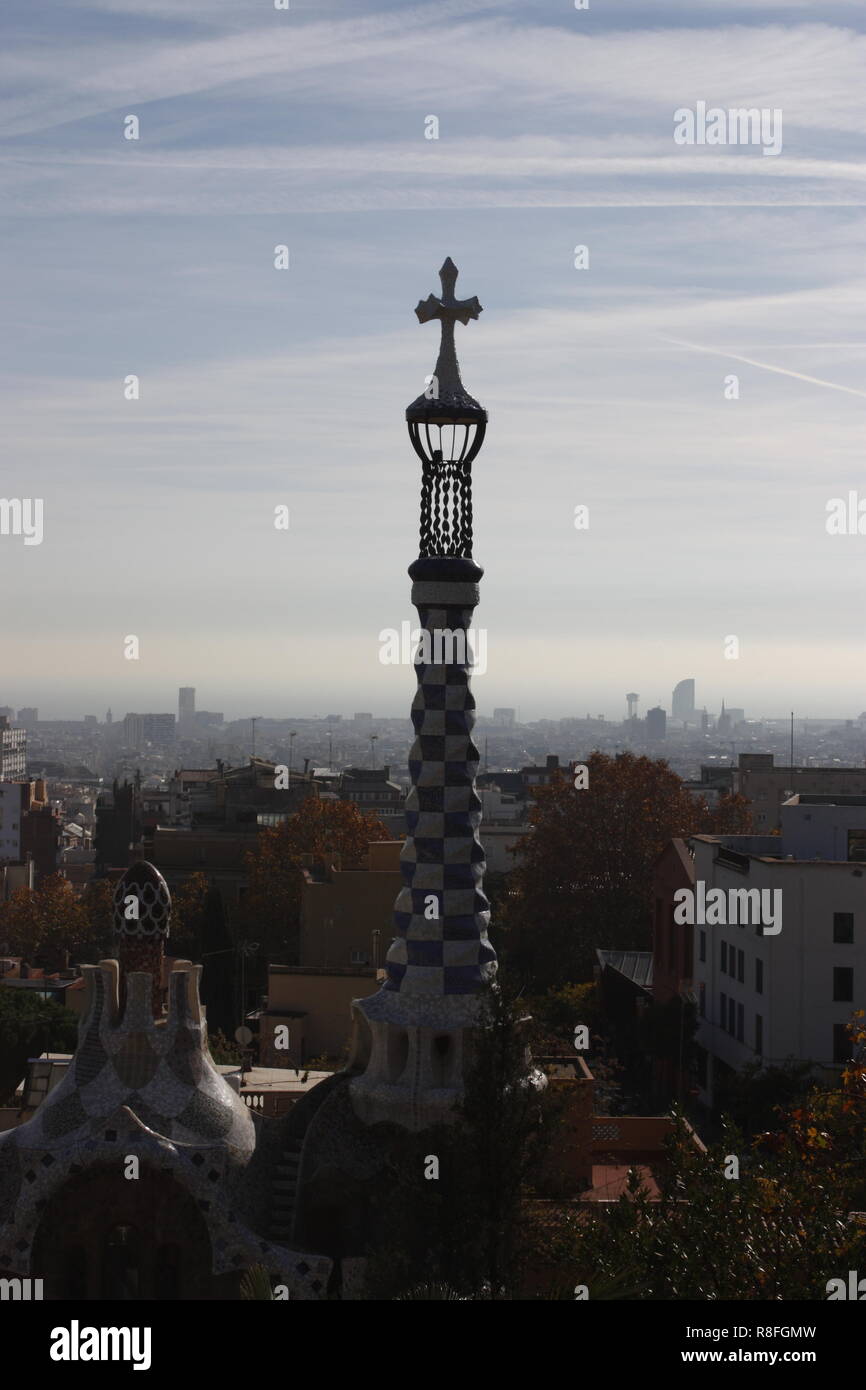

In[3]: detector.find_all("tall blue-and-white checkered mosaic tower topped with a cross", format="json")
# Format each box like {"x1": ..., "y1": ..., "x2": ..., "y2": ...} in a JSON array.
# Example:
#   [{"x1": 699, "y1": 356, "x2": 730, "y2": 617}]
[{"x1": 352, "y1": 259, "x2": 496, "y2": 1130}]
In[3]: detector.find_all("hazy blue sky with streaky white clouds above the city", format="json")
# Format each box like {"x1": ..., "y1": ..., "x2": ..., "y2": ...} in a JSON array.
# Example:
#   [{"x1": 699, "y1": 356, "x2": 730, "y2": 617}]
[{"x1": 0, "y1": 0, "x2": 866, "y2": 720}]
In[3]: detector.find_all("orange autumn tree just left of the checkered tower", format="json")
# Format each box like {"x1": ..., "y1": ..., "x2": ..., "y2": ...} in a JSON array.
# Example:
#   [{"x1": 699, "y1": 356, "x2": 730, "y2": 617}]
[{"x1": 240, "y1": 796, "x2": 389, "y2": 963}]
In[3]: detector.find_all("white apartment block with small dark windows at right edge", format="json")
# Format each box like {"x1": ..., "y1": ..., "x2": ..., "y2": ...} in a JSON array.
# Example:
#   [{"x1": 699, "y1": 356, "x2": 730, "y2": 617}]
[{"x1": 692, "y1": 795, "x2": 866, "y2": 1104}]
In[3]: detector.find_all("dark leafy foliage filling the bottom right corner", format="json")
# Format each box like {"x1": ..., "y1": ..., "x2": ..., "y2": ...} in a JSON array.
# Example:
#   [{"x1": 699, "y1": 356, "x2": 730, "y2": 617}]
[{"x1": 557, "y1": 1013, "x2": 866, "y2": 1300}]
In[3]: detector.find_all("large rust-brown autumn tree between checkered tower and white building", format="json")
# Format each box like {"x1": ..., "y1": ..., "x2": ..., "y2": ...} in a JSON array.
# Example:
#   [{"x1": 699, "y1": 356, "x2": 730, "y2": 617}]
[{"x1": 498, "y1": 753, "x2": 749, "y2": 992}]
